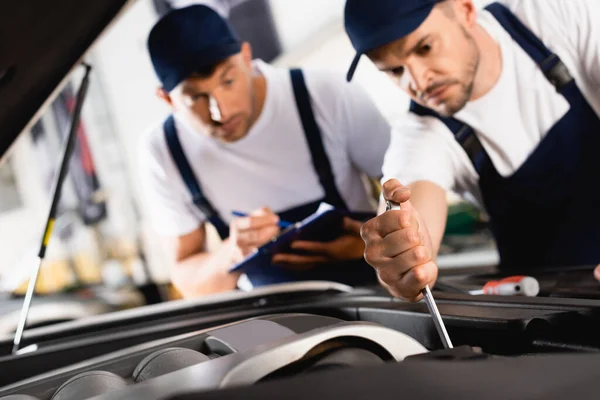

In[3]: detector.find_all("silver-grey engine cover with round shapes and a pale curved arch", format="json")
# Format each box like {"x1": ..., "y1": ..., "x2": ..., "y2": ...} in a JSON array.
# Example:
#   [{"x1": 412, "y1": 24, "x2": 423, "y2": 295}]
[{"x1": 0, "y1": 314, "x2": 427, "y2": 400}]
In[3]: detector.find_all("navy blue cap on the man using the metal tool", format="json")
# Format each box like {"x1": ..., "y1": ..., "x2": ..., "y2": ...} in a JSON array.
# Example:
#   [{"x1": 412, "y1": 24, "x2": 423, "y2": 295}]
[{"x1": 344, "y1": 0, "x2": 442, "y2": 81}]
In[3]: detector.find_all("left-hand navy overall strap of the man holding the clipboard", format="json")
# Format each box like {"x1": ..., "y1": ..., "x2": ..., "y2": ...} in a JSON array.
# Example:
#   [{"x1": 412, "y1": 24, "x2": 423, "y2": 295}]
[{"x1": 163, "y1": 115, "x2": 229, "y2": 239}]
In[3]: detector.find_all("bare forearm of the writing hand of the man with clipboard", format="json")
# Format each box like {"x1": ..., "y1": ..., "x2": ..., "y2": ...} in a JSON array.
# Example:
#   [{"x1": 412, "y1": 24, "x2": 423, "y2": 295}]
[{"x1": 171, "y1": 241, "x2": 240, "y2": 298}]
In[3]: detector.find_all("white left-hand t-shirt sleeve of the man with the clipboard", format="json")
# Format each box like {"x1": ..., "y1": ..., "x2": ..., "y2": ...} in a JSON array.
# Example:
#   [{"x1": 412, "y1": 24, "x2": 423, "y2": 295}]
[{"x1": 138, "y1": 131, "x2": 204, "y2": 237}]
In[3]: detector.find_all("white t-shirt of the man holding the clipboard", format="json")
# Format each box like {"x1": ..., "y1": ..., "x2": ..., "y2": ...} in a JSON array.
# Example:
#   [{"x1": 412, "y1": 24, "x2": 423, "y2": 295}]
[{"x1": 139, "y1": 60, "x2": 391, "y2": 236}]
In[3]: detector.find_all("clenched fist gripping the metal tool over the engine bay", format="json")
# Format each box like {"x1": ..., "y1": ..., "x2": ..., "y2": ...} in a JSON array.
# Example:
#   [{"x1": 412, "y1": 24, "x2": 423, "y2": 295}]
[{"x1": 361, "y1": 179, "x2": 438, "y2": 301}]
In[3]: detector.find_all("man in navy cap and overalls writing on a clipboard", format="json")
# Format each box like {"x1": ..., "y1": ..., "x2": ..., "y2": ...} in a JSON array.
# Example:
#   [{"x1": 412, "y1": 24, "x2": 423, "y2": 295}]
[{"x1": 139, "y1": 5, "x2": 390, "y2": 297}]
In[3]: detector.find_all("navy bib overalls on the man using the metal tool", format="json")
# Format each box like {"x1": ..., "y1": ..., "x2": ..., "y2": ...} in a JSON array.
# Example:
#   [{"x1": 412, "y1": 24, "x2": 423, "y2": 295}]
[{"x1": 411, "y1": 3, "x2": 600, "y2": 272}]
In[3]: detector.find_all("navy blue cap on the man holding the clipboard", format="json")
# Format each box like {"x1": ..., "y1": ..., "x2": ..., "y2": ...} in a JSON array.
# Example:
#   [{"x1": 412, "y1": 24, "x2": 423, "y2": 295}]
[{"x1": 147, "y1": 4, "x2": 242, "y2": 92}]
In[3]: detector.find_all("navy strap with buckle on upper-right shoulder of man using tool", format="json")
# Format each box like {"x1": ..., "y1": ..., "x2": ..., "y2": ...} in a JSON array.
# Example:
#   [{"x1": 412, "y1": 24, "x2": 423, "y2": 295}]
[{"x1": 485, "y1": 3, "x2": 573, "y2": 92}]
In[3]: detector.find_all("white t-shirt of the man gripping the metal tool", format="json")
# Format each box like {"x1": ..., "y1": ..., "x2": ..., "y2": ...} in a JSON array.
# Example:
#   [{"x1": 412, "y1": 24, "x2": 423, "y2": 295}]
[{"x1": 383, "y1": 0, "x2": 600, "y2": 211}]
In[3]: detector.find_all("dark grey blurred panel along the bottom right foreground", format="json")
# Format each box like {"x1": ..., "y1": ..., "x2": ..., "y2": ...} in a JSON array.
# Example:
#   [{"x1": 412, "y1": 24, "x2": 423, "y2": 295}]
[{"x1": 165, "y1": 348, "x2": 600, "y2": 400}]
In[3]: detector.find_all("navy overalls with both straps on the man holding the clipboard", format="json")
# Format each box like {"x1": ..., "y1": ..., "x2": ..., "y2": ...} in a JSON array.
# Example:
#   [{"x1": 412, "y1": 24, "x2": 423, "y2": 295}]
[{"x1": 163, "y1": 69, "x2": 377, "y2": 287}]
